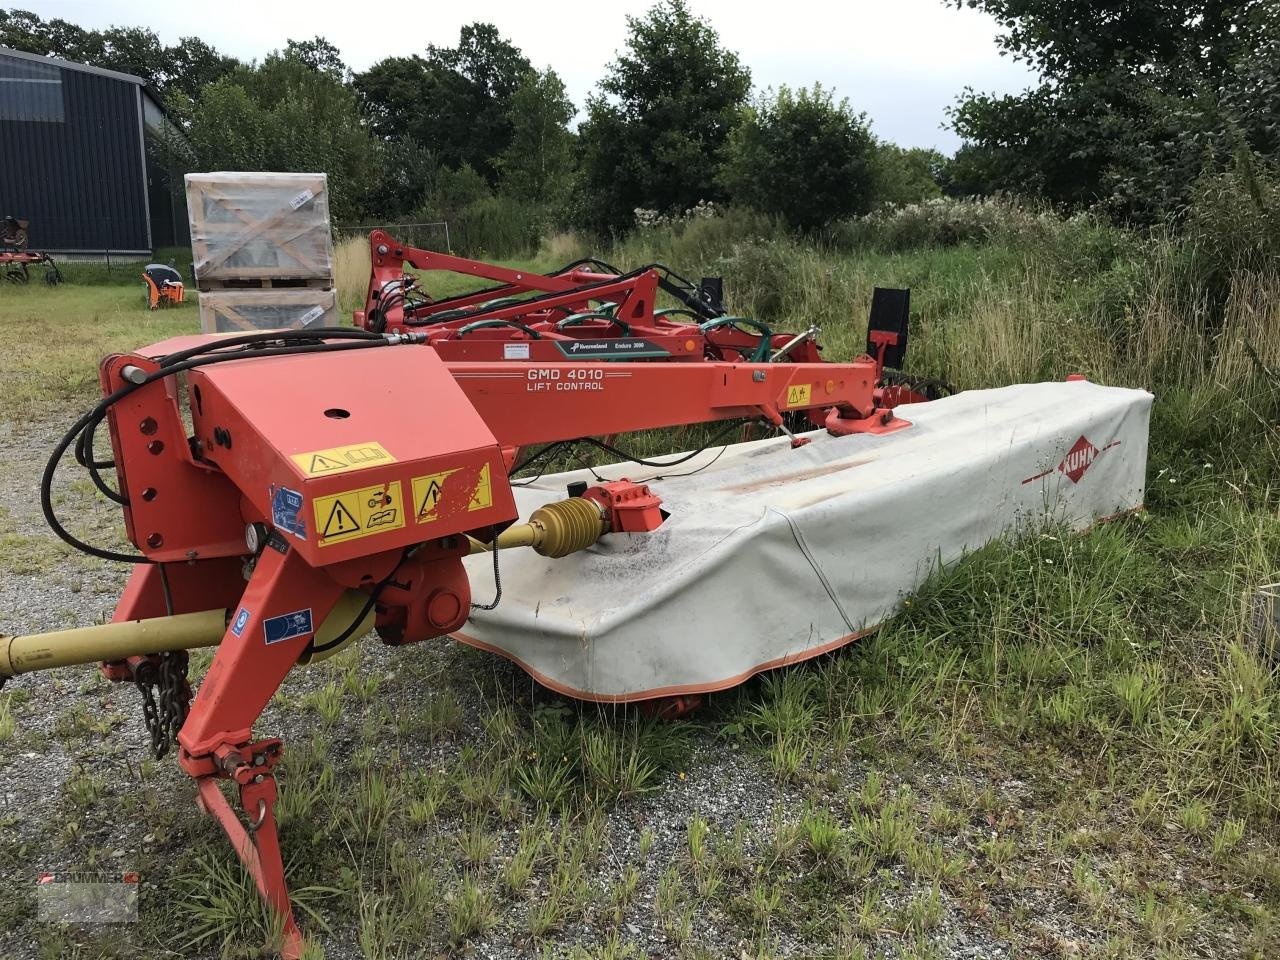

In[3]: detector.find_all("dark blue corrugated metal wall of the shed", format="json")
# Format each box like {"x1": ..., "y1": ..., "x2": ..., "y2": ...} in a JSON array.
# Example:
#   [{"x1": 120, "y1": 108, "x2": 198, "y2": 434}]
[{"x1": 0, "y1": 54, "x2": 151, "y2": 252}]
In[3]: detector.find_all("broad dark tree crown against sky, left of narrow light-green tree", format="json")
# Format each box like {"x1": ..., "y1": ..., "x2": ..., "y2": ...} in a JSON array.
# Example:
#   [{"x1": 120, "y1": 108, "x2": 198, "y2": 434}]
[{"x1": 353, "y1": 23, "x2": 532, "y2": 183}]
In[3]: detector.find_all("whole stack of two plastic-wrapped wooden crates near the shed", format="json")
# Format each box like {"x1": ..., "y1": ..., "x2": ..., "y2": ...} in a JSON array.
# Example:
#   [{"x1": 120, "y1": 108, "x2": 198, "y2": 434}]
[{"x1": 187, "y1": 173, "x2": 338, "y2": 333}]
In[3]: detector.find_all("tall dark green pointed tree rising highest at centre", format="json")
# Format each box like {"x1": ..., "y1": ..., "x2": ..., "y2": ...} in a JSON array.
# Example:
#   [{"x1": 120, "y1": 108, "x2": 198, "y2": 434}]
[{"x1": 579, "y1": 0, "x2": 751, "y2": 230}]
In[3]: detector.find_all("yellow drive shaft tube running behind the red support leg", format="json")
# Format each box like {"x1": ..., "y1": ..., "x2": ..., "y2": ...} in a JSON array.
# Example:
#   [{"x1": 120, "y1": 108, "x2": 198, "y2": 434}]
[{"x1": 0, "y1": 590, "x2": 374, "y2": 677}]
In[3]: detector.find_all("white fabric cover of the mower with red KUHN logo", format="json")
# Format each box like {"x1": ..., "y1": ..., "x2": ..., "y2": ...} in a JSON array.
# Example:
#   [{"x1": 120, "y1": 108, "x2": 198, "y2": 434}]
[{"x1": 454, "y1": 381, "x2": 1152, "y2": 700}]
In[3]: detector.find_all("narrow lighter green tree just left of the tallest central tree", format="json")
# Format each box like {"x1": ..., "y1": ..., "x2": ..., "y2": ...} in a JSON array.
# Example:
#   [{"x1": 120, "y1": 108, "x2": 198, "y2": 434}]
[{"x1": 497, "y1": 67, "x2": 575, "y2": 210}]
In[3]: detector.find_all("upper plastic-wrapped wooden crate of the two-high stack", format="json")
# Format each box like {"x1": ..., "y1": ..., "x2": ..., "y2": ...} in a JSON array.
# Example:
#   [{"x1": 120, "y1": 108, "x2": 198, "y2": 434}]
[{"x1": 187, "y1": 173, "x2": 333, "y2": 289}]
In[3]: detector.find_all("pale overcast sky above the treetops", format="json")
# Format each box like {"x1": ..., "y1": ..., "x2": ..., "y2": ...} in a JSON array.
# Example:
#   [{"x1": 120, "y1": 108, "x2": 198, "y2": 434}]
[{"x1": 30, "y1": 0, "x2": 1034, "y2": 152}]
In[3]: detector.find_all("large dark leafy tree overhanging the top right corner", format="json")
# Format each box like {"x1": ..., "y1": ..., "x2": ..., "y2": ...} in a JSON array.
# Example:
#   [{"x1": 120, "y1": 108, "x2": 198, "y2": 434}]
[{"x1": 951, "y1": 0, "x2": 1276, "y2": 223}]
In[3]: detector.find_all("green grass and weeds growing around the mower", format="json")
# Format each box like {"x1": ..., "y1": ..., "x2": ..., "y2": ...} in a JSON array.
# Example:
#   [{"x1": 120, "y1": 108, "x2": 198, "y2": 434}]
[{"x1": 0, "y1": 215, "x2": 1280, "y2": 957}]
